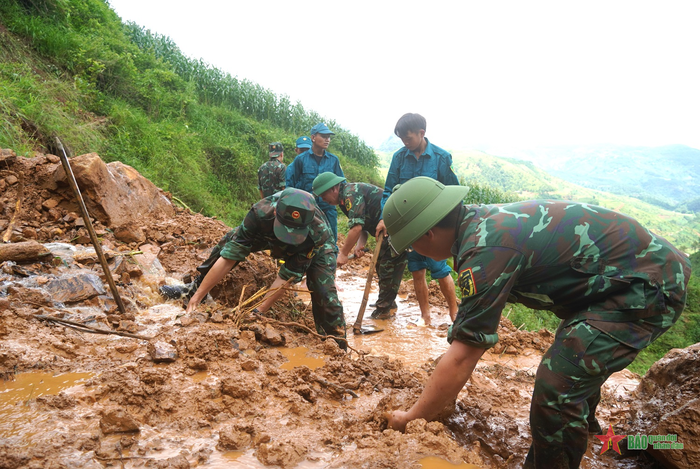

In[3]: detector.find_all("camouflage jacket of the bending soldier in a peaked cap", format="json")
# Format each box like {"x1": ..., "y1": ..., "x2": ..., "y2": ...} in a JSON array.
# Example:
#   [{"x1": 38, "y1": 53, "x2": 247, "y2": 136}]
[{"x1": 221, "y1": 194, "x2": 338, "y2": 280}]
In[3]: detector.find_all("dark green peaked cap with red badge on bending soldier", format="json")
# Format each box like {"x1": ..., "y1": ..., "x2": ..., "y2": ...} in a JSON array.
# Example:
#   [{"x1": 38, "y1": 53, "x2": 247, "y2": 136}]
[{"x1": 274, "y1": 188, "x2": 316, "y2": 245}]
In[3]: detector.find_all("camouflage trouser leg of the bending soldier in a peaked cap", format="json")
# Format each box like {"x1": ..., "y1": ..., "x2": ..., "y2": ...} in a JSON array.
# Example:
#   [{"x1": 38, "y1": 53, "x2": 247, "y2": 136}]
[{"x1": 306, "y1": 244, "x2": 347, "y2": 349}]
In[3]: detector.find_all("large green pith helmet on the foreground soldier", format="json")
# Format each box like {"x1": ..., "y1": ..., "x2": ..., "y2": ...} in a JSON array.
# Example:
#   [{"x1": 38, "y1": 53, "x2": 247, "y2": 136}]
[{"x1": 383, "y1": 176, "x2": 469, "y2": 254}]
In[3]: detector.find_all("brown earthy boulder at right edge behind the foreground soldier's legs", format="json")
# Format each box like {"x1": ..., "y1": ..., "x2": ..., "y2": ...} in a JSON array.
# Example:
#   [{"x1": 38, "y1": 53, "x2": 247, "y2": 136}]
[{"x1": 628, "y1": 343, "x2": 700, "y2": 469}]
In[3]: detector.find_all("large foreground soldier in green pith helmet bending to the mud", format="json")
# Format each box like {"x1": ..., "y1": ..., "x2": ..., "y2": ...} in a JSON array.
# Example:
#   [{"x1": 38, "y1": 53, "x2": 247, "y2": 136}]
[{"x1": 384, "y1": 177, "x2": 690, "y2": 469}]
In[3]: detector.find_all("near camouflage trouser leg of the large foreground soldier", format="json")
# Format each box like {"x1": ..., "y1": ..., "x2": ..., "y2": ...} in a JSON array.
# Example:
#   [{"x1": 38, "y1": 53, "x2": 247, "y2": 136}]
[{"x1": 523, "y1": 321, "x2": 639, "y2": 469}]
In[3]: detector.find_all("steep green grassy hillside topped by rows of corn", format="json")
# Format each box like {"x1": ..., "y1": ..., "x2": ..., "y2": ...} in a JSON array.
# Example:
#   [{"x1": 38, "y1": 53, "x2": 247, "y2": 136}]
[{"x1": 0, "y1": 0, "x2": 379, "y2": 225}]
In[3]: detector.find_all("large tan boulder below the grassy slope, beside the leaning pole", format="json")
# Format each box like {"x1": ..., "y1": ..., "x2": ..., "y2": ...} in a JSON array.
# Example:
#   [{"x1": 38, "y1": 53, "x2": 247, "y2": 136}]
[{"x1": 54, "y1": 153, "x2": 175, "y2": 231}]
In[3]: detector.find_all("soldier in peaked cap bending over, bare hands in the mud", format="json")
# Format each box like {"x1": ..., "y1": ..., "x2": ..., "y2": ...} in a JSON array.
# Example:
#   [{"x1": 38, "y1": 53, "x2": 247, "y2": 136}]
[{"x1": 160, "y1": 188, "x2": 347, "y2": 349}]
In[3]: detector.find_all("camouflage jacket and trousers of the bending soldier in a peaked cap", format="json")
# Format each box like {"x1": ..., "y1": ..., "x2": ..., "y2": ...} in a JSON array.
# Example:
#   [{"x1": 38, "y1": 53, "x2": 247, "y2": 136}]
[{"x1": 197, "y1": 193, "x2": 345, "y2": 340}]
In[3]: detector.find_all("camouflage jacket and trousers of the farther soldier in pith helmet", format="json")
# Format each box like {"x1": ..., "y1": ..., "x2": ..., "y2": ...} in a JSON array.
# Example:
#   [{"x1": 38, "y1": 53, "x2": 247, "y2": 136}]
[{"x1": 338, "y1": 182, "x2": 408, "y2": 315}]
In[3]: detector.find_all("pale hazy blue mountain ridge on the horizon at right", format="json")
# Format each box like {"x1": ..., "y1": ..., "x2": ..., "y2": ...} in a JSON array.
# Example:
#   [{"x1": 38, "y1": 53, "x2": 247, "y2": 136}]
[{"x1": 482, "y1": 145, "x2": 700, "y2": 211}]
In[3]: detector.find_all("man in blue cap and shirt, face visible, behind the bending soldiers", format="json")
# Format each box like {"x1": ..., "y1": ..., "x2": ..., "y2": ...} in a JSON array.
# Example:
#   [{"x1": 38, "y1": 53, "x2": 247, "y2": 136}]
[{"x1": 287, "y1": 123, "x2": 345, "y2": 242}]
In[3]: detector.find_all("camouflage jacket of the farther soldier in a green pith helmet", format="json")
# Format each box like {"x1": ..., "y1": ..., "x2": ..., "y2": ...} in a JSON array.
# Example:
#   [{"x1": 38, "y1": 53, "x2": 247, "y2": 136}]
[{"x1": 338, "y1": 182, "x2": 384, "y2": 236}]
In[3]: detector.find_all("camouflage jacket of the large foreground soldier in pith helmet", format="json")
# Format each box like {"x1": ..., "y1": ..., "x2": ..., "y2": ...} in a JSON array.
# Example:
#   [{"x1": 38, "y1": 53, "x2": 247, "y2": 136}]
[{"x1": 449, "y1": 200, "x2": 690, "y2": 348}]
